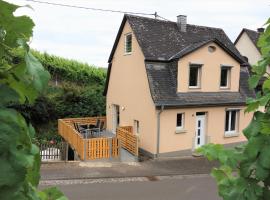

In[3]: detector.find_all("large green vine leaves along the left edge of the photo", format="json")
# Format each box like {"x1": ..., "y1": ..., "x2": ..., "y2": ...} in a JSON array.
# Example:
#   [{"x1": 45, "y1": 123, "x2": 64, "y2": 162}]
[{"x1": 0, "y1": 0, "x2": 66, "y2": 200}]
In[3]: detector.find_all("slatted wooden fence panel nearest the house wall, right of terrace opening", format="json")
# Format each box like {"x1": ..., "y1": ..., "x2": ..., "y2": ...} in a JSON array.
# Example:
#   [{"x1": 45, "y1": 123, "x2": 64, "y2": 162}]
[{"x1": 116, "y1": 126, "x2": 139, "y2": 156}]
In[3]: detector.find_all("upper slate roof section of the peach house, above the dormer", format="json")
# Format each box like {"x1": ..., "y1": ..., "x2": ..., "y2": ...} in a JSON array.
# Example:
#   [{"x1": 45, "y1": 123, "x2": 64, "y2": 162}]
[{"x1": 109, "y1": 15, "x2": 244, "y2": 63}]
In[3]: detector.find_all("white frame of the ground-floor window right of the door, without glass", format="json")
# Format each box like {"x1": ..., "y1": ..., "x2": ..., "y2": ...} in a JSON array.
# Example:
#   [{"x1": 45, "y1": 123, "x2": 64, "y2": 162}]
[{"x1": 224, "y1": 108, "x2": 240, "y2": 137}]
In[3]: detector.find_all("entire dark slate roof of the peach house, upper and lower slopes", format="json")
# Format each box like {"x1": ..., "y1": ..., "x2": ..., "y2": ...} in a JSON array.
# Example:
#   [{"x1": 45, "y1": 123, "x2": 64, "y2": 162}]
[{"x1": 104, "y1": 15, "x2": 254, "y2": 107}]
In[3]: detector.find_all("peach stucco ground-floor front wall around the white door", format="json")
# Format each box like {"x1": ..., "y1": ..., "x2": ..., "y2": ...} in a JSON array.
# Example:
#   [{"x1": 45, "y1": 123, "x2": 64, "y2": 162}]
[{"x1": 160, "y1": 106, "x2": 252, "y2": 154}]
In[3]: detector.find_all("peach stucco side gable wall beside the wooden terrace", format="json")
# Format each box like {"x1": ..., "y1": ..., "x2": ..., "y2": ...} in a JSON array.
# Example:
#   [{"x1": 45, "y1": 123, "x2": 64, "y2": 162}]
[{"x1": 106, "y1": 23, "x2": 157, "y2": 152}]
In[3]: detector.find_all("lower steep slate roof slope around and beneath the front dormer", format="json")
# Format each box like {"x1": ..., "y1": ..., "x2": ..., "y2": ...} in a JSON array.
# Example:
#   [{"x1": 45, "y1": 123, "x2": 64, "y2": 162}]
[{"x1": 146, "y1": 62, "x2": 254, "y2": 108}]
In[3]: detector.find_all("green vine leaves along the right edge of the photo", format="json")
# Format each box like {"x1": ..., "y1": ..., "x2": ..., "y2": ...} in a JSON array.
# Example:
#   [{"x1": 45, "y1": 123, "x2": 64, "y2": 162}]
[{"x1": 198, "y1": 18, "x2": 270, "y2": 200}]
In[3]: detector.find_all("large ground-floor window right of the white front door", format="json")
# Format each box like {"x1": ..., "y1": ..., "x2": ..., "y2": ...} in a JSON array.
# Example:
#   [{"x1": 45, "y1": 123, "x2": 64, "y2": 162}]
[{"x1": 225, "y1": 110, "x2": 239, "y2": 136}]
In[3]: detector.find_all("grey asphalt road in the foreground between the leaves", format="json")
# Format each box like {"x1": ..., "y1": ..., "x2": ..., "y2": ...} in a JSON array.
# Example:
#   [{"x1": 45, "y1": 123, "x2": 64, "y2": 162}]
[{"x1": 41, "y1": 175, "x2": 220, "y2": 200}]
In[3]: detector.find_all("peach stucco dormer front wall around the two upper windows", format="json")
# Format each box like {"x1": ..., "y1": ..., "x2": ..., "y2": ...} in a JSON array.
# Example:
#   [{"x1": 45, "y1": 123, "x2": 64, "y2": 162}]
[{"x1": 177, "y1": 43, "x2": 240, "y2": 92}]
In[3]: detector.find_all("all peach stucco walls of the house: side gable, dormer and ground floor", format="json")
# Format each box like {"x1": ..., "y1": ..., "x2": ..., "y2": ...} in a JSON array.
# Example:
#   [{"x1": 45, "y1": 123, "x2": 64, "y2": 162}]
[{"x1": 106, "y1": 22, "x2": 252, "y2": 158}]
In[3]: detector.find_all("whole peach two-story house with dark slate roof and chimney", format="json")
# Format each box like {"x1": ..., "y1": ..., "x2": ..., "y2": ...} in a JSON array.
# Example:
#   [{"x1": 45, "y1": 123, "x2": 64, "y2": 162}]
[{"x1": 104, "y1": 15, "x2": 254, "y2": 157}]
